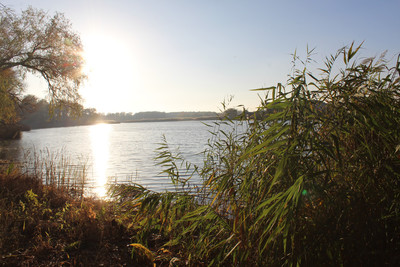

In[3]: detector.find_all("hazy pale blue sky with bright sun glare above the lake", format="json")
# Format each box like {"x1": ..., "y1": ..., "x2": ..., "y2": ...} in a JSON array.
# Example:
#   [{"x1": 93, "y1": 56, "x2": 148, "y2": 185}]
[{"x1": 0, "y1": 0, "x2": 400, "y2": 112}]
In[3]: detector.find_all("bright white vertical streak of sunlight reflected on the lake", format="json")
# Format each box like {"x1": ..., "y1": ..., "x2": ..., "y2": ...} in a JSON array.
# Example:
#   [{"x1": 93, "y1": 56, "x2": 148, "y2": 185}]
[{"x1": 90, "y1": 124, "x2": 111, "y2": 197}]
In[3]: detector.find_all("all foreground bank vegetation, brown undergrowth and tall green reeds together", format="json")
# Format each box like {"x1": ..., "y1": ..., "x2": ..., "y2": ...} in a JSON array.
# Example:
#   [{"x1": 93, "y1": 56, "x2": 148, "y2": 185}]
[{"x1": 0, "y1": 45, "x2": 400, "y2": 266}]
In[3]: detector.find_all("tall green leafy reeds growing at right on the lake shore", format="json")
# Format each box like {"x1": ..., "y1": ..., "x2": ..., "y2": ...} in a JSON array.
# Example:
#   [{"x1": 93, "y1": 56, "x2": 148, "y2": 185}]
[{"x1": 112, "y1": 44, "x2": 400, "y2": 266}]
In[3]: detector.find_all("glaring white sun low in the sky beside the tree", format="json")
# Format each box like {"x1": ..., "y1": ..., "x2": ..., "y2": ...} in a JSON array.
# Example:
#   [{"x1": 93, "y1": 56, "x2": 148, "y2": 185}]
[{"x1": 81, "y1": 34, "x2": 138, "y2": 113}]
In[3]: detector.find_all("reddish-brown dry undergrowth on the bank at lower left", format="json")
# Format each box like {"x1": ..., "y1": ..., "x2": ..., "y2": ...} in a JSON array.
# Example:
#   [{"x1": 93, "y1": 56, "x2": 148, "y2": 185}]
[{"x1": 0, "y1": 166, "x2": 176, "y2": 266}]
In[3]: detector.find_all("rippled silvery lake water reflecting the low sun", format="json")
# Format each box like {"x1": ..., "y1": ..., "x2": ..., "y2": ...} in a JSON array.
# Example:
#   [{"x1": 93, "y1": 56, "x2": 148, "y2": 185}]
[{"x1": 0, "y1": 121, "x2": 225, "y2": 196}]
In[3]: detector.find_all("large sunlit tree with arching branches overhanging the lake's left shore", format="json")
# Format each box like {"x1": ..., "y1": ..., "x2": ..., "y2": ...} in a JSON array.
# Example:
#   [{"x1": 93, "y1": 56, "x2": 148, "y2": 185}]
[{"x1": 0, "y1": 5, "x2": 85, "y2": 124}]
